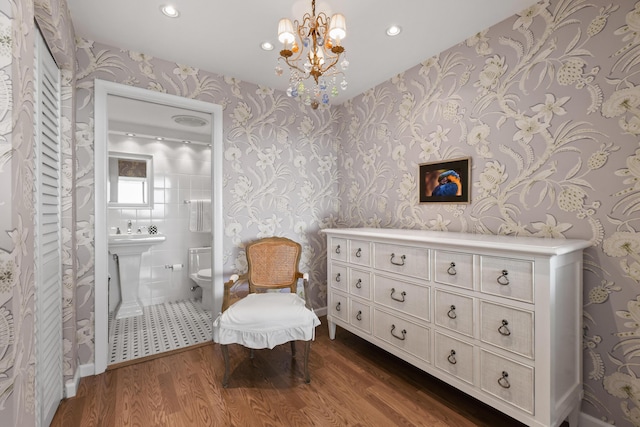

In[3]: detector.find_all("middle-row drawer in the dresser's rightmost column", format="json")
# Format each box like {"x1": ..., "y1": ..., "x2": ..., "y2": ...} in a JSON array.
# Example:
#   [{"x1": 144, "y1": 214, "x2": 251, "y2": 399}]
[{"x1": 480, "y1": 301, "x2": 534, "y2": 359}]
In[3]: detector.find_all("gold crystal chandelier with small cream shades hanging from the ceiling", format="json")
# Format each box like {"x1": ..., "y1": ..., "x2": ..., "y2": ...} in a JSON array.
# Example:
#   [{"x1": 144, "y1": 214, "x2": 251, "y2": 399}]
[{"x1": 276, "y1": 0, "x2": 349, "y2": 110}]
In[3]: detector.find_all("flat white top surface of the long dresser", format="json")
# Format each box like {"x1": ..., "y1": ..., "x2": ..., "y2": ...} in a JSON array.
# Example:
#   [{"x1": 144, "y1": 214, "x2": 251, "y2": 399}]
[{"x1": 321, "y1": 228, "x2": 591, "y2": 255}]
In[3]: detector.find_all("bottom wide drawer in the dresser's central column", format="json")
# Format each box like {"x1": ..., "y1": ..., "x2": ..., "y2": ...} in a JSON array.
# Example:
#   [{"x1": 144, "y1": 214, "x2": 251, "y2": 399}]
[{"x1": 373, "y1": 309, "x2": 429, "y2": 362}]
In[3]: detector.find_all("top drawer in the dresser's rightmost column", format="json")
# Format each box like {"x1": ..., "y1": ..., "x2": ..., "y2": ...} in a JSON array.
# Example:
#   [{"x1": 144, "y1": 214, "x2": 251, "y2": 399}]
[{"x1": 480, "y1": 256, "x2": 534, "y2": 303}]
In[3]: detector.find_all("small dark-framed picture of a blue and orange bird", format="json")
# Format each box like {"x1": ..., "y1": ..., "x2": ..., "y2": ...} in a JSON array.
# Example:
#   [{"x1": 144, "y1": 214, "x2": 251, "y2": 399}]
[{"x1": 418, "y1": 157, "x2": 471, "y2": 203}]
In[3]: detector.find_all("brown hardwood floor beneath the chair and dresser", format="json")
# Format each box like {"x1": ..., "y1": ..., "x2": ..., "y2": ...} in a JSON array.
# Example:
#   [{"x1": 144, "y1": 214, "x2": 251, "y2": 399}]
[{"x1": 51, "y1": 318, "x2": 522, "y2": 427}]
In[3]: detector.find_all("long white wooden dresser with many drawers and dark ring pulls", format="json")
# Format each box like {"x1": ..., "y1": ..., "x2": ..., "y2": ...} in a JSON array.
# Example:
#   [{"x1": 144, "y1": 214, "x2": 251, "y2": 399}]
[{"x1": 323, "y1": 228, "x2": 589, "y2": 427}]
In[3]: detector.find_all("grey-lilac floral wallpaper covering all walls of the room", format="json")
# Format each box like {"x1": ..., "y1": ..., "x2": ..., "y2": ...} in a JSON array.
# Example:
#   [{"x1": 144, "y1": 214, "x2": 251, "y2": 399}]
[{"x1": 0, "y1": 0, "x2": 640, "y2": 426}]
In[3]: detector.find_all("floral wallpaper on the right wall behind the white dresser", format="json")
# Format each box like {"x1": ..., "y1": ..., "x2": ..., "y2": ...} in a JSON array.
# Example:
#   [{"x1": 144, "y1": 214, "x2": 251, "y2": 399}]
[{"x1": 338, "y1": 0, "x2": 640, "y2": 426}]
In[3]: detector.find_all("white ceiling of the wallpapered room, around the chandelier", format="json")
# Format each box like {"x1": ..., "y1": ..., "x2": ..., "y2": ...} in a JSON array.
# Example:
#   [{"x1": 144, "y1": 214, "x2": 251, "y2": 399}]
[{"x1": 67, "y1": 0, "x2": 536, "y2": 104}]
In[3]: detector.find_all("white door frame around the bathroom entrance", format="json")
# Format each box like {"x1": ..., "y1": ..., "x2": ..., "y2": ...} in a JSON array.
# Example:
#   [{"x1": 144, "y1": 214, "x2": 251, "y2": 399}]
[{"x1": 94, "y1": 79, "x2": 224, "y2": 375}]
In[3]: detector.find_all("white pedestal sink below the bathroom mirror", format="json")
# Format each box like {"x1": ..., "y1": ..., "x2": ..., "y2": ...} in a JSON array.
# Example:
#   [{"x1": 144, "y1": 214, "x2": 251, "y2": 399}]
[{"x1": 109, "y1": 234, "x2": 167, "y2": 319}]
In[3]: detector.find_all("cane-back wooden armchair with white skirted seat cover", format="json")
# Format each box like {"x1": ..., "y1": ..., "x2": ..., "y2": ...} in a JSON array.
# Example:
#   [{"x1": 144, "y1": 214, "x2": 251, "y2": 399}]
[{"x1": 213, "y1": 237, "x2": 320, "y2": 387}]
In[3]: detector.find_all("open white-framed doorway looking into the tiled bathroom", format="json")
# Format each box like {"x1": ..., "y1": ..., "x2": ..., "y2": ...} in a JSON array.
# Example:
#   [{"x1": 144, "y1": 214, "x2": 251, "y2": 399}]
[{"x1": 95, "y1": 80, "x2": 222, "y2": 374}]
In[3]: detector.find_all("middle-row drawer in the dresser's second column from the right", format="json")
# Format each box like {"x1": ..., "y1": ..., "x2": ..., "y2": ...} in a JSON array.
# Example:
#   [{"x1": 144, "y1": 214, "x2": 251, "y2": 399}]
[{"x1": 433, "y1": 289, "x2": 473, "y2": 337}]
